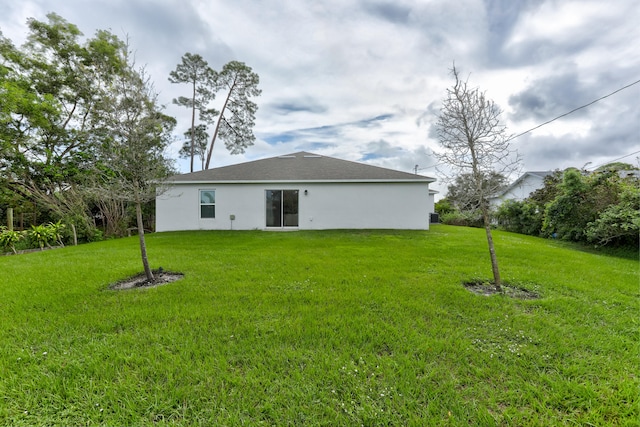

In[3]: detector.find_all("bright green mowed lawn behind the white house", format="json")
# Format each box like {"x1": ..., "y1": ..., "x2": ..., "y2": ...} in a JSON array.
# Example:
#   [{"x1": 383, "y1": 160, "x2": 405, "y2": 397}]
[{"x1": 0, "y1": 225, "x2": 640, "y2": 426}]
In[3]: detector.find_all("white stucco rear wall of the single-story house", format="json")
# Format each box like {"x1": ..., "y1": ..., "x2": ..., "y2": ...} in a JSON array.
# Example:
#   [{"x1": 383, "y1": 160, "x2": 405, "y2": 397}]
[{"x1": 156, "y1": 182, "x2": 429, "y2": 231}]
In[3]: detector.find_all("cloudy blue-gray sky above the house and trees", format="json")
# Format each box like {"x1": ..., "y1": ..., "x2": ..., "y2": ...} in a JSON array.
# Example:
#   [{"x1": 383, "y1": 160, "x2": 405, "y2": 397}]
[{"x1": 0, "y1": 0, "x2": 640, "y2": 197}]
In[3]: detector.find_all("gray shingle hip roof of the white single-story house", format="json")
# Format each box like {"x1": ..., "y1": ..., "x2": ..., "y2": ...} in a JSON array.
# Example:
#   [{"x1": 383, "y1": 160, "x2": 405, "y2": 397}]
[{"x1": 168, "y1": 151, "x2": 435, "y2": 183}]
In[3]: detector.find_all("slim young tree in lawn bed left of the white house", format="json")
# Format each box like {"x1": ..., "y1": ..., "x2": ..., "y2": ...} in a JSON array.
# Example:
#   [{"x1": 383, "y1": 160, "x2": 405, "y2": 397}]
[{"x1": 95, "y1": 51, "x2": 176, "y2": 281}]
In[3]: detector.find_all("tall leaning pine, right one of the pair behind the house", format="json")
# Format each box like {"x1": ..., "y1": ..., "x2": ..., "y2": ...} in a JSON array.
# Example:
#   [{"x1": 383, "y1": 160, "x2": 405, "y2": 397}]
[{"x1": 205, "y1": 61, "x2": 262, "y2": 169}]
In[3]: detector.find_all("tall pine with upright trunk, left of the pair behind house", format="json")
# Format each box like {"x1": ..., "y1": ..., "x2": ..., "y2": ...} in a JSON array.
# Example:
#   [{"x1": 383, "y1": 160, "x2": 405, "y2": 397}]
[{"x1": 169, "y1": 52, "x2": 218, "y2": 172}]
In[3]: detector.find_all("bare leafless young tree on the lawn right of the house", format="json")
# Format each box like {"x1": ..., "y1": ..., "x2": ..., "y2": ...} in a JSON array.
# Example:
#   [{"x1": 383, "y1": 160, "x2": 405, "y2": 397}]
[{"x1": 435, "y1": 65, "x2": 519, "y2": 290}]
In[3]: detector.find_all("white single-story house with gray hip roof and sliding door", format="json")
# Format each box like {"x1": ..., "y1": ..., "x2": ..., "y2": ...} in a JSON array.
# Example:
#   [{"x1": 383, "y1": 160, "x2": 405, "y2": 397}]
[{"x1": 156, "y1": 152, "x2": 435, "y2": 231}]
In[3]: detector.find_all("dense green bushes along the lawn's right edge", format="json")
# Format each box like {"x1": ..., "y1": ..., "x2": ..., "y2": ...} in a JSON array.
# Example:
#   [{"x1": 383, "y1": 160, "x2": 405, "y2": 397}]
[{"x1": 496, "y1": 164, "x2": 640, "y2": 247}]
